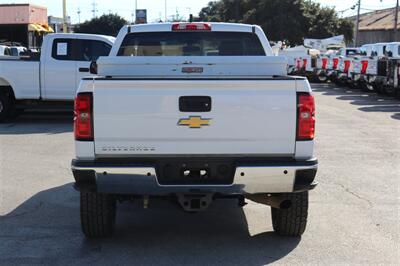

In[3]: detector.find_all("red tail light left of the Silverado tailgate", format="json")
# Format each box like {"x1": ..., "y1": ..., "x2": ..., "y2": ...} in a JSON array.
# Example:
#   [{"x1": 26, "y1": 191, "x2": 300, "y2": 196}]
[{"x1": 74, "y1": 93, "x2": 93, "y2": 141}]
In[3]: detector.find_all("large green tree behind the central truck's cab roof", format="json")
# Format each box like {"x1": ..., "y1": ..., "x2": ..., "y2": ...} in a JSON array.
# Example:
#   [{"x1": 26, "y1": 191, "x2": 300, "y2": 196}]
[{"x1": 196, "y1": 0, "x2": 353, "y2": 45}]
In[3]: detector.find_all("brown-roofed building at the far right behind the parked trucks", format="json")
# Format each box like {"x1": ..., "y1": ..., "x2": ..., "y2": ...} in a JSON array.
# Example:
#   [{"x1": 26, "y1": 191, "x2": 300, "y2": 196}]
[{"x1": 350, "y1": 8, "x2": 400, "y2": 46}]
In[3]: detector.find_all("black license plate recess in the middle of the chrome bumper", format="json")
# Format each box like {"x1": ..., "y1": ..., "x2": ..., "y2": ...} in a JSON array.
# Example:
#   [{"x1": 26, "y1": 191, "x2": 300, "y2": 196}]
[{"x1": 157, "y1": 161, "x2": 235, "y2": 185}]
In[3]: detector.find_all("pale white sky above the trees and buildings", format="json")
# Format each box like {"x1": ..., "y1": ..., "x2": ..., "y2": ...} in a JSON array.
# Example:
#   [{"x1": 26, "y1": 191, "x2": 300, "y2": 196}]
[{"x1": 0, "y1": 0, "x2": 396, "y2": 23}]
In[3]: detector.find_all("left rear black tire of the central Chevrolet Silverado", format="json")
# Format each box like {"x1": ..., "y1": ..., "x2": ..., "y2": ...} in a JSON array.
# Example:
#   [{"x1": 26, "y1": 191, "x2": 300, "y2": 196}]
[{"x1": 80, "y1": 192, "x2": 117, "y2": 238}]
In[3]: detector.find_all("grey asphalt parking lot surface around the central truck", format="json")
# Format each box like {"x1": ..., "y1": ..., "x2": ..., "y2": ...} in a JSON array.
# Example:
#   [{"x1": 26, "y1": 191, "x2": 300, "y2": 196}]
[{"x1": 0, "y1": 84, "x2": 400, "y2": 265}]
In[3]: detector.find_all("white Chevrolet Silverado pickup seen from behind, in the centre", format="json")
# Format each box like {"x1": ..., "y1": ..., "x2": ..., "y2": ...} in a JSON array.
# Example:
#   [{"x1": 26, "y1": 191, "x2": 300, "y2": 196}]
[{"x1": 71, "y1": 23, "x2": 318, "y2": 237}]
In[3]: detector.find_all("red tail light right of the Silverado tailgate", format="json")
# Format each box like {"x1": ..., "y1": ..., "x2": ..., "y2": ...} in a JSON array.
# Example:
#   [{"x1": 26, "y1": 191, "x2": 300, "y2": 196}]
[{"x1": 297, "y1": 92, "x2": 315, "y2": 140}]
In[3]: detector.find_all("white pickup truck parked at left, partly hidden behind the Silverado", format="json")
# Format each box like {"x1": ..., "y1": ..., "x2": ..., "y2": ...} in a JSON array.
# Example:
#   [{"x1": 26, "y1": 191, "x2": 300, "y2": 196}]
[{"x1": 0, "y1": 33, "x2": 115, "y2": 122}]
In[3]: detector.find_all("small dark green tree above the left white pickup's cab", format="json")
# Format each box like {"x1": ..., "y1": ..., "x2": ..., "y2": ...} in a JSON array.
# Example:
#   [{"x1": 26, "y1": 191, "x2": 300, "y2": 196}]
[{"x1": 74, "y1": 14, "x2": 128, "y2": 36}]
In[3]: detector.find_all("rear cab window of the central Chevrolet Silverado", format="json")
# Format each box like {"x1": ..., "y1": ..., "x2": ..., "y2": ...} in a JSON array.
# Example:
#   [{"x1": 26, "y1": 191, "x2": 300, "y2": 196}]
[{"x1": 118, "y1": 31, "x2": 266, "y2": 56}]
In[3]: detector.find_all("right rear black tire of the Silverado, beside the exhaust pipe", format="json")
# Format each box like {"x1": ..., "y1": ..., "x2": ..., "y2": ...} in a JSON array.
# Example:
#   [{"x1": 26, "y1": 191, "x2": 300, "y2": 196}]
[{"x1": 271, "y1": 191, "x2": 308, "y2": 237}]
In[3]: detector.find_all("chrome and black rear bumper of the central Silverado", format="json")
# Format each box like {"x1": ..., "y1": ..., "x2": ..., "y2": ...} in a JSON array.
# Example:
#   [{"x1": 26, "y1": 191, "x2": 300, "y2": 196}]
[{"x1": 72, "y1": 159, "x2": 318, "y2": 195}]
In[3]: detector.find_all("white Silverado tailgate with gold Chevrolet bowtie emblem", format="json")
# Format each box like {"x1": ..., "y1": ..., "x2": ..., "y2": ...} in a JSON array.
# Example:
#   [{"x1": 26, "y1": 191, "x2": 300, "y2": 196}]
[{"x1": 93, "y1": 79, "x2": 296, "y2": 157}]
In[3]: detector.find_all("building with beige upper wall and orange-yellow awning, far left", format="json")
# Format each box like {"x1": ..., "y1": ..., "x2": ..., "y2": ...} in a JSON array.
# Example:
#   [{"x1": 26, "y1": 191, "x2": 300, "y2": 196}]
[{"x1": 0, "y1": 4, "x2": 53, "y2": 48}]
